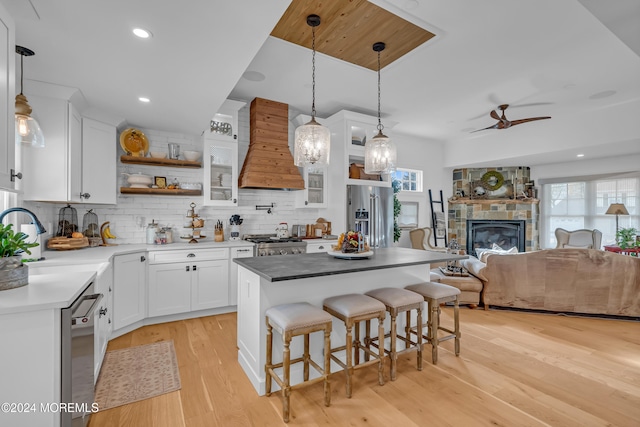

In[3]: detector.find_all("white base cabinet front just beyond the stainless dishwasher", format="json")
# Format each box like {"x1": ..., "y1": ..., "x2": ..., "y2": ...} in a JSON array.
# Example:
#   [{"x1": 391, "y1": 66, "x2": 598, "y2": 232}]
[{"x1": 94, "y1": 262, "x2": 113, "y2": 381}]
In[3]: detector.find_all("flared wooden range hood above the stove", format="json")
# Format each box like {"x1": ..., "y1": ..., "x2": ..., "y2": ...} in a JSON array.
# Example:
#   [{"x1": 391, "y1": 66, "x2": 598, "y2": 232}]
[{"x1": 238, "y1": 98, "x2": 304, "y2": 190}]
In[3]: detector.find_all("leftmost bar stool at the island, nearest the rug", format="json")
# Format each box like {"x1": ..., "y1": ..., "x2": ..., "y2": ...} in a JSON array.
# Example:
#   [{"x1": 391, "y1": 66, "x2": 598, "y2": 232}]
[{"x1": 264, "y1": 303, "x2": 333, "y2": 423}]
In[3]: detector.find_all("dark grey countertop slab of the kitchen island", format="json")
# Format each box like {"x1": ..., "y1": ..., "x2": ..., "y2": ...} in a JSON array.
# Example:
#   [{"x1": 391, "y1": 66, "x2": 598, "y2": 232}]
[{"x1": 233, "y1": 248, "x2": 467, "y2": 282}]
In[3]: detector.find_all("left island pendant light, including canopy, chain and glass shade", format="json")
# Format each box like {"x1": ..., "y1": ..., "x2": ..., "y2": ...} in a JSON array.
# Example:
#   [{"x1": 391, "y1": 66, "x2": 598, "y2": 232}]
[{"x1": 293, "y1": 15, "x2": 331, "y2": 167}]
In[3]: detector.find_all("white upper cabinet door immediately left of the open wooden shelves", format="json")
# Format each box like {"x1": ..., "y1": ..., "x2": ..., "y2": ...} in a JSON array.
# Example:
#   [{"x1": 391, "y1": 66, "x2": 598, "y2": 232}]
[{"x1": 81, "y1": 117, "x2": 117, "y2": 205}]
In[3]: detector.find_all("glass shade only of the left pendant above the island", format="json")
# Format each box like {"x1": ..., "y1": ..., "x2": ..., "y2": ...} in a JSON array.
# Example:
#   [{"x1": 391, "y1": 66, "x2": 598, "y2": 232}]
[{"x1": 293, "y1": 118, "x2": 331, "y2": 167}]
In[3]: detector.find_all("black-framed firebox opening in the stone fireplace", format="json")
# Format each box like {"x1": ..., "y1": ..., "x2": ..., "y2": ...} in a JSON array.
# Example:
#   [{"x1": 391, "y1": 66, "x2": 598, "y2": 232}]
[{"x1": 466, "y1": 219, "x2": 526, "y2": 256}]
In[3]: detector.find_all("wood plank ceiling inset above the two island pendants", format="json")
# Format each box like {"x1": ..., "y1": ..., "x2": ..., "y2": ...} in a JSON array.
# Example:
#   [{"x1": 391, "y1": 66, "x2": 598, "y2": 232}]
[{"x1": 271, "y1": 0, "x2": 435, "y2": 71}]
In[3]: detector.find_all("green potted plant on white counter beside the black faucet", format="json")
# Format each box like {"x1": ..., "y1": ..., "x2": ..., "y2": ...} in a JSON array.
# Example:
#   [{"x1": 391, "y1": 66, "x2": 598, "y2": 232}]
[{"x1": 0, "y1": 224, "x2": 38, "y2": 290}]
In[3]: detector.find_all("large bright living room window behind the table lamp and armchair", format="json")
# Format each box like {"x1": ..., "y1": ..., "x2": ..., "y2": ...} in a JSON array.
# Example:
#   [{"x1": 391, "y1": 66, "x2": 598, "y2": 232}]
[{"x1": 540, "y1": 177, "x2": 640, "y2": 248}]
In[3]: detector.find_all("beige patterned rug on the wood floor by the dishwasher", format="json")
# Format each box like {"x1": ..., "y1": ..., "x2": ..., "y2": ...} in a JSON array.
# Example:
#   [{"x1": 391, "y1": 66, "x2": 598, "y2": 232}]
[{"x1": 95, "y1": 341, "x2": 180, "y2": 411}]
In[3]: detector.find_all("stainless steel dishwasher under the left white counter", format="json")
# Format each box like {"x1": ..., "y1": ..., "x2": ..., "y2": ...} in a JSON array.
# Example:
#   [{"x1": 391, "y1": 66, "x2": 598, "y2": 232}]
[{"x1": 60, "y1": 282, "x2": 102, "y2": 427}]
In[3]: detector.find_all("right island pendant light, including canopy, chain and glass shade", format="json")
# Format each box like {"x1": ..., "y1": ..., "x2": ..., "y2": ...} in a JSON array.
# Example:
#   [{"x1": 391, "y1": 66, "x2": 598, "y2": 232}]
[{"x1": 364, "y1": 42, "x2": 397, "y2": 174}]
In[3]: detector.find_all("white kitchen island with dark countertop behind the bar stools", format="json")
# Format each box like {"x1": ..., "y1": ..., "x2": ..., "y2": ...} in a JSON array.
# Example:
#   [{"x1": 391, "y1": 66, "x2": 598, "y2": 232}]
[{"x1": 234, "y1": 248, "x2": 467, "y2": 395}]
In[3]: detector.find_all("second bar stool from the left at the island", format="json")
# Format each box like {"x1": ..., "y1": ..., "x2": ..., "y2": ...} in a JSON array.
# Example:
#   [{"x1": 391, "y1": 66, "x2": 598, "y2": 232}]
[{"x1": 323, "y1": 294, "x2": 386, "y2": 398}]
